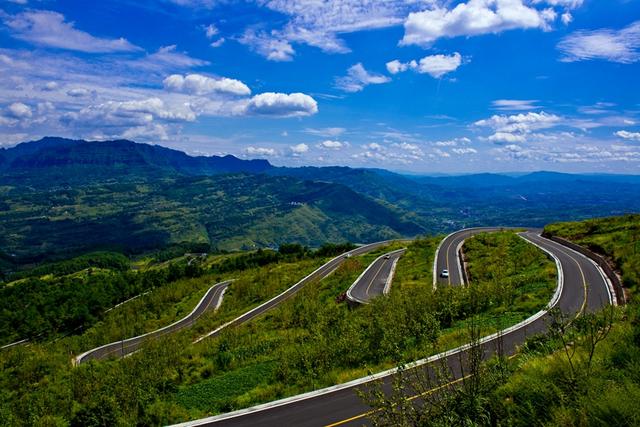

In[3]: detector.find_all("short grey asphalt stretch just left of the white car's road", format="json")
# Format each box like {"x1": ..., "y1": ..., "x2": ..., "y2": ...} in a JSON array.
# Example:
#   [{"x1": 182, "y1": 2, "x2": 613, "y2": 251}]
[{"x1": 347, "y1": 249, "x2": 405, "y2": 304}]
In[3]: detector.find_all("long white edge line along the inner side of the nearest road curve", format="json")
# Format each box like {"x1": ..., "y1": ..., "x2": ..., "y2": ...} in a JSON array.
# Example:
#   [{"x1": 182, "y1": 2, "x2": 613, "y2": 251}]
[{"x1": 171, "y1": 236, "x2": 564, "y2": 427}]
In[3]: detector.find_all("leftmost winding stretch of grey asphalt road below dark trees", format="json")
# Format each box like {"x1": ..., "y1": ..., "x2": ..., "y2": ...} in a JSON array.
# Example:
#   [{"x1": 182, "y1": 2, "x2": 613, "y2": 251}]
[{"x1": 74, "y1": 280, "x2": 231, "y2": 365}]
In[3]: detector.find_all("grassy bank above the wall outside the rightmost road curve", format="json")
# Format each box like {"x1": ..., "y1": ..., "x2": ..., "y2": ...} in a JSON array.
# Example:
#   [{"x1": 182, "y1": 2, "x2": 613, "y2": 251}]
[{"x1": 544, "y1": 215, "x2": 640, "y2": 290}]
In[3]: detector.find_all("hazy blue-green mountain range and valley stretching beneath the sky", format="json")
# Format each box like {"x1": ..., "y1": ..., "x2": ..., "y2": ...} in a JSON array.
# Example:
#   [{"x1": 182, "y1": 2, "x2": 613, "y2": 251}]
[{"x1": 0, "y1": 137, "x2": 640, "y2": 262}]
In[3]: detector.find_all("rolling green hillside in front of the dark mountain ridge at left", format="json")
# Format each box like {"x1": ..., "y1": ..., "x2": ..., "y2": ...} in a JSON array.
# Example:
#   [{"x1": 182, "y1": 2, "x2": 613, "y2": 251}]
[{"x1": 0, "y1": 175, "x2": 421, "y2": 262}]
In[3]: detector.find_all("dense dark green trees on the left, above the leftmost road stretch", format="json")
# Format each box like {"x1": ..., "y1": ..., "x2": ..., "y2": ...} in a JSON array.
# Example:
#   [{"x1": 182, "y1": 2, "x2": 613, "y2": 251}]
[{"x1": 0, "y1": 253, "x2": 203, "y2": 344}]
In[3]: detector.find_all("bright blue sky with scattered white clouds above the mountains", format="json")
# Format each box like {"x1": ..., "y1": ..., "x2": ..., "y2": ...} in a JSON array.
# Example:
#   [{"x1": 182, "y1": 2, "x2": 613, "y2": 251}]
[{"x1": 0, "y1": 0, "x2": 640, "y2": 173}]
